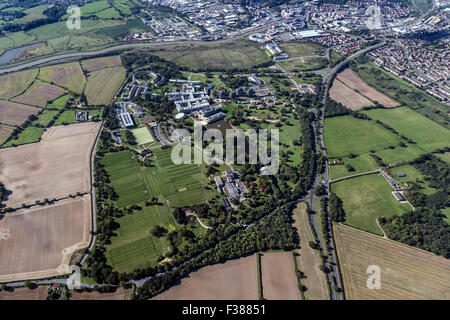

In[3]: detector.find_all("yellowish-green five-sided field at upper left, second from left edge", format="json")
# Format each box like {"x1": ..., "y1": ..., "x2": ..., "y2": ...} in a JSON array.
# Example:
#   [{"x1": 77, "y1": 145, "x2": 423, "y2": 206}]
[{"x1": 39, "y1": 62, "x2": 86, "y2": 93}]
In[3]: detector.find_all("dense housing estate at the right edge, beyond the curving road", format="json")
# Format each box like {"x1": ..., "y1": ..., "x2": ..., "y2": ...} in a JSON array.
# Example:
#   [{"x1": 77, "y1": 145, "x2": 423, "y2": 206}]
[{"x1": 367, "y1": 39, "x2": 450, "y2": 104}]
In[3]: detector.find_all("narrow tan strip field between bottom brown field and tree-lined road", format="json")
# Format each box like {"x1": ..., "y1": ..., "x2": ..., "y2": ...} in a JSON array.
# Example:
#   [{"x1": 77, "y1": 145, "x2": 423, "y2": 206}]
[{"x1": 294, "y1": 202, "x2": 329, "y2": 300}]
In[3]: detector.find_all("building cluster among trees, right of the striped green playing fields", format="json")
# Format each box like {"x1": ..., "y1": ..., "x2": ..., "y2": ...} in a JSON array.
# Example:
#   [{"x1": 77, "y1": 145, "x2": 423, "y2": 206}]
[{"x1": 214, "y1": 170, "x2": 248, "y2": 209}]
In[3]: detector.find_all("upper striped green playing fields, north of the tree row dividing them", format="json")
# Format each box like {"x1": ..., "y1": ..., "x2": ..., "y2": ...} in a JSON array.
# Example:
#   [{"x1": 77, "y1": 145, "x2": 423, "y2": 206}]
[{"x1": 103, "y1": 149, "x2": 213, "y2": 207}]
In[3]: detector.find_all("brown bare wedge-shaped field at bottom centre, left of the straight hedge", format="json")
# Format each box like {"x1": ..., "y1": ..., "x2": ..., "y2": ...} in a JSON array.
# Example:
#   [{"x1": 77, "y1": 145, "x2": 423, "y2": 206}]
[{"x1": 153, "y1": 255, "x2": 258, "y2": 300}]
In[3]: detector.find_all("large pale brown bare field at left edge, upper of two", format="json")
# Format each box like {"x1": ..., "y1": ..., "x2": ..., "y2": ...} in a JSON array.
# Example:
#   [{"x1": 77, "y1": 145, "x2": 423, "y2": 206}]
[{"x1": 0, "y1": 122, "x2": 100, "y2": 208}]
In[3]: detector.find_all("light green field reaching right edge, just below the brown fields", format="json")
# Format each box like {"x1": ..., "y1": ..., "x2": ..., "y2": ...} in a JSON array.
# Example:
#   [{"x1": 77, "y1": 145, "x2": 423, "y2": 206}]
[{"x1": 364, "y1": 107, "x2": 450, "y2": 151}]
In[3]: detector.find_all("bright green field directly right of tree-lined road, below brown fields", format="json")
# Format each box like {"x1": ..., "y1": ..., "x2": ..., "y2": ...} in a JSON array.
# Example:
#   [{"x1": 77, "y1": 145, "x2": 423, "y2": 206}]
[{"x1": 324, "y1": 116, "x2": 400, "y2": 157}]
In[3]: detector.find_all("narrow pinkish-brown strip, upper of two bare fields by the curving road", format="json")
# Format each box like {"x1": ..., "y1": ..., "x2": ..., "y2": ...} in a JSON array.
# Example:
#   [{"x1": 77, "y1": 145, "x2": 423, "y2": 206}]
[{"x1": 337, "y1": 68, "x2": 400, "y2": 108}]
